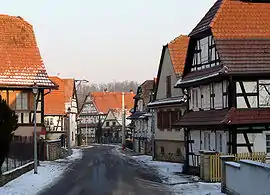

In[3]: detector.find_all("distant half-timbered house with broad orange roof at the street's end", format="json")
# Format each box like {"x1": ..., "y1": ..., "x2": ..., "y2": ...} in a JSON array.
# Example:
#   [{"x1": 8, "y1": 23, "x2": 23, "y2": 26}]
[{"x1": 79, "y1": 92, "x2": 134, "y2": 143}]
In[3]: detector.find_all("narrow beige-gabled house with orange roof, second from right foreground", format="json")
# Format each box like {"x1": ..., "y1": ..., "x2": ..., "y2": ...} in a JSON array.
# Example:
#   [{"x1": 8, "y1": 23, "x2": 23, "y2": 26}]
[{"x1": 148, "y1": 35, "x2": 189, "y2": 162}]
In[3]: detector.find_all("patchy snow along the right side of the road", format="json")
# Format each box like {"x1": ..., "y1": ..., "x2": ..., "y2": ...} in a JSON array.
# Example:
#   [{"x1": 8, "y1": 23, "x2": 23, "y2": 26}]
[{"x1": 132, "y1": 155, "x2": 224, "y2": 195}]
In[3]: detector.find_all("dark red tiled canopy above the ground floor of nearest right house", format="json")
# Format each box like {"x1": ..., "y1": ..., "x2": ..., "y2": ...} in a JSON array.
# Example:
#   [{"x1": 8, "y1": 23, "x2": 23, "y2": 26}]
[{"x1": 173, "y1": 108, "x2": 270, "y2": 130}]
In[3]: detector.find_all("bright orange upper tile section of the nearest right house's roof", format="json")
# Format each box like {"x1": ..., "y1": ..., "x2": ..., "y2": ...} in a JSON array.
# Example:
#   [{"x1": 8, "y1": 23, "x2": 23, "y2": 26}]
[{"x1": 210, "y1": 0, "x2": 270, "y2": 39}]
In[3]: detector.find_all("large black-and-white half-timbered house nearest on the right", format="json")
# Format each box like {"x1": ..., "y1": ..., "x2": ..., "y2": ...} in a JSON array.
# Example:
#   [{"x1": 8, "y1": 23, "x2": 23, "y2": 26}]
[{"x1": 176, "y1": 0, "x2": 270, "y2": 168}]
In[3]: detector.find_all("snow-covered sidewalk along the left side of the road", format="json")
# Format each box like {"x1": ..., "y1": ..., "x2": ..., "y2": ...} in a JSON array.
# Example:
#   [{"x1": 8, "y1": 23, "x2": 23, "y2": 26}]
[{"x1": 0, "y1": 149, "x2": 82, "y2": 195}]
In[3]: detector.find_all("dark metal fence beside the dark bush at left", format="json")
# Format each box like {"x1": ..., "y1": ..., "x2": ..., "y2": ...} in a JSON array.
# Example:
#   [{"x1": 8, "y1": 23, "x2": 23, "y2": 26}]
[{"x1": 1, "y1": 136, "x2": 34, "y2": 172}]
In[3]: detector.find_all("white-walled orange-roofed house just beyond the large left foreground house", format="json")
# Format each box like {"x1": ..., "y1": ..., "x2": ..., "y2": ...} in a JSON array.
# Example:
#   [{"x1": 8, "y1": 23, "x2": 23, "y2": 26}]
[{"x1": 45, "y1": 77, "x2": 78, "y2": 146}]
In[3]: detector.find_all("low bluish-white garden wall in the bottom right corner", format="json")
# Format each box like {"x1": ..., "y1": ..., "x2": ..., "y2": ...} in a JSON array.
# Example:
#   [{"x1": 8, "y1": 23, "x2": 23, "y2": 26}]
[{"x1": 225, "y1": 160, "x2": 270, "y2": 195}]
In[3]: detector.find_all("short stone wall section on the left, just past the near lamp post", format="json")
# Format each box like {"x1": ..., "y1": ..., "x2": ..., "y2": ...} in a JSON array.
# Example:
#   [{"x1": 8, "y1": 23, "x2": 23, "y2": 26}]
[{"x1": 44, "y1": 140, "x2": 62, "y2": 161}]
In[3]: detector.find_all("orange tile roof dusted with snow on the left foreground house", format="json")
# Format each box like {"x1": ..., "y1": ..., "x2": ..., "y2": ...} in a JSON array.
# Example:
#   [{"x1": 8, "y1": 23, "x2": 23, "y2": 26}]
[{"x1": 0, "y1": 15, "x2": 55, "y2": 88}]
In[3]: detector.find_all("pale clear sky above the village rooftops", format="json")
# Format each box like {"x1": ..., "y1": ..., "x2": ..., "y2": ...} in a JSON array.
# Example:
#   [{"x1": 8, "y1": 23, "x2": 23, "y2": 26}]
[{"x1": 0, "y1": 0, "x2": 216, "y2": 83}]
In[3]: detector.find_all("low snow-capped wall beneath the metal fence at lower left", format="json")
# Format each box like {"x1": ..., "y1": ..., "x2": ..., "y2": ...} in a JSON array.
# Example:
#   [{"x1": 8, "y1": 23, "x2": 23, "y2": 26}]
[{"x1": 0, "y1": 162, "x2": 34, "y2": 186}]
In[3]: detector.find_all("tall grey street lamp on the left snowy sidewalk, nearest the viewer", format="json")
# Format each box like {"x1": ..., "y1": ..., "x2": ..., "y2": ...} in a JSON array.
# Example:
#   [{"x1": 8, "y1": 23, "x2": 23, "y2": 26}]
[{"x1": 32, "y1": 83, "x2": 38, "y2": 174}]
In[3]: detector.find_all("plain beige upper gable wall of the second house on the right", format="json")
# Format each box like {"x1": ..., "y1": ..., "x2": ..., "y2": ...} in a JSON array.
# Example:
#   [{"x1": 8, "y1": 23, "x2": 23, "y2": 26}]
[{"x1": 156, "y1": 47, "x2": 182, "y2": 100}]
